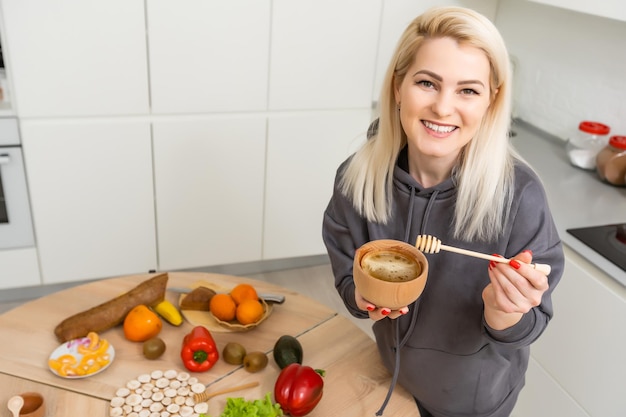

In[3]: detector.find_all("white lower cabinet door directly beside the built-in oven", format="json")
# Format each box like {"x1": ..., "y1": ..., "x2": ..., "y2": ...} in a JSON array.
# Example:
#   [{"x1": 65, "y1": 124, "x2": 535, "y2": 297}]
[{"x1": 21, "y1": 119, "x2": 157, "y2": 284}]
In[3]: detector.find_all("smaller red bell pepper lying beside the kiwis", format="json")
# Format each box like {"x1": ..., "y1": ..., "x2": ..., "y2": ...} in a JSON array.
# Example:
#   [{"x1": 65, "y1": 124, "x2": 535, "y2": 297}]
[{"x1": 180, "y1": 326, "x2": 220, "y2": 372}]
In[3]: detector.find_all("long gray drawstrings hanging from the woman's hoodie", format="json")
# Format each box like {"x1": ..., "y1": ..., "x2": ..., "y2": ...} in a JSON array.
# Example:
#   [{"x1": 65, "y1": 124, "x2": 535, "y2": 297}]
[{"x1": 376, "y1": 187, "x2": 439, "y2": 416}]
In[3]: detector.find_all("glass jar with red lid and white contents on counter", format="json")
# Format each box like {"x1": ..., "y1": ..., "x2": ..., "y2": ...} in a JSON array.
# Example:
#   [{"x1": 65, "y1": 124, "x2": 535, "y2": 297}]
[{"x1": 566, "y1": 120, "x2": 611, "y2": 170}]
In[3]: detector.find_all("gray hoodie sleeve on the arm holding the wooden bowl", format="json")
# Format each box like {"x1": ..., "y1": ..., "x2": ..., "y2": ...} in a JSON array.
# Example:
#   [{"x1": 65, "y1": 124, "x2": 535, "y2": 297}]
[{"x1": 322, "y1": 165, "x2": 369, "y2": 318}]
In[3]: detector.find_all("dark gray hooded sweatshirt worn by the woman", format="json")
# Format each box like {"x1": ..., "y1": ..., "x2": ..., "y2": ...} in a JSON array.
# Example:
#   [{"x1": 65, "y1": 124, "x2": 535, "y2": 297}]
[{"x1": 322, "y1": 148, "x2": 564, "y2": 417}]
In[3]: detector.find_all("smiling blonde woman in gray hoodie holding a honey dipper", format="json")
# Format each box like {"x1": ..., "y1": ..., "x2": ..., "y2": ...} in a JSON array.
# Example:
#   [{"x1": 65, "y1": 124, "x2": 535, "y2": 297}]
[{"x1": 323, "y1": 7, "x2": 563, "y2": 417}]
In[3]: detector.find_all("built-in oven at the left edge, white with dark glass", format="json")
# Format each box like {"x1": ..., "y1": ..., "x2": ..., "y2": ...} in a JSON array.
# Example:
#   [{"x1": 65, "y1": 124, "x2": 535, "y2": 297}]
[{"x1": 0, "y1": 117, "x2": 35, "y2": 250}]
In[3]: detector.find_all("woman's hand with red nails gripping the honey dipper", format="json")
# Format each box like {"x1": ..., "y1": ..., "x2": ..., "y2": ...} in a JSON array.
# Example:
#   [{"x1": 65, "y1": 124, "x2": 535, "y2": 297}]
[{"x1": 483, "y1": 251, "x2": 548, "y2": 330}]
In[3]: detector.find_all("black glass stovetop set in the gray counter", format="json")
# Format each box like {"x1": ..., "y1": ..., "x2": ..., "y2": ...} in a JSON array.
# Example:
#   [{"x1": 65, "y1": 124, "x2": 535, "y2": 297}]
[{"x1": 567, "y1": 223, "x2": 626, "y2": 271}]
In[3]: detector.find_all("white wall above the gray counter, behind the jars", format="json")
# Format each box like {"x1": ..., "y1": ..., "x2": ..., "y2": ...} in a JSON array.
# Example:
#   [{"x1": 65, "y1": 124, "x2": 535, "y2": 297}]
[{"x1": 495, "y1": 0, "x2": 626, "y2": 139}]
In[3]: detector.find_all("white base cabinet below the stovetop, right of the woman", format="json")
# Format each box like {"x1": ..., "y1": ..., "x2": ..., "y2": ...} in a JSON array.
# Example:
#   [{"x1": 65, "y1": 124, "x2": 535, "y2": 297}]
[{"x1": 520, "y1": 246, "x2": 626, "y2": 417}]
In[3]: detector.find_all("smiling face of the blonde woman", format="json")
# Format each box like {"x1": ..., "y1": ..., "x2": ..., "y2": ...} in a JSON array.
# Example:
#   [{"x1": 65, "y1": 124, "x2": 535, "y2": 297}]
[{"x1": 395, "y1": 38, "x2": 491, "y2": 185}]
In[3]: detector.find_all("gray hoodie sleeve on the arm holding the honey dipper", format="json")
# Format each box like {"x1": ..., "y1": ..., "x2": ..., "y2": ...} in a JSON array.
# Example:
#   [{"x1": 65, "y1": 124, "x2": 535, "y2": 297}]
[{"x1": 483, "y1": 164, "x2": 565, "y2": 348}]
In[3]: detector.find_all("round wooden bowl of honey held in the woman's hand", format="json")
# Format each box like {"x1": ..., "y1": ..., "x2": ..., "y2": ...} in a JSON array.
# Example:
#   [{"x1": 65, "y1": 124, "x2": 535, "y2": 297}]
[{"x1": 353, "y1": 239, "x2": 428, "y2": 310}]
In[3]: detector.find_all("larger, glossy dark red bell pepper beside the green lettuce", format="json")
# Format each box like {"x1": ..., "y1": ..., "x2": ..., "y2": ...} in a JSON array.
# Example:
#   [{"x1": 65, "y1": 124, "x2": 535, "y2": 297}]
[{"x1": 274, "y1": 363, "x2": 324, "y2": 417}]
